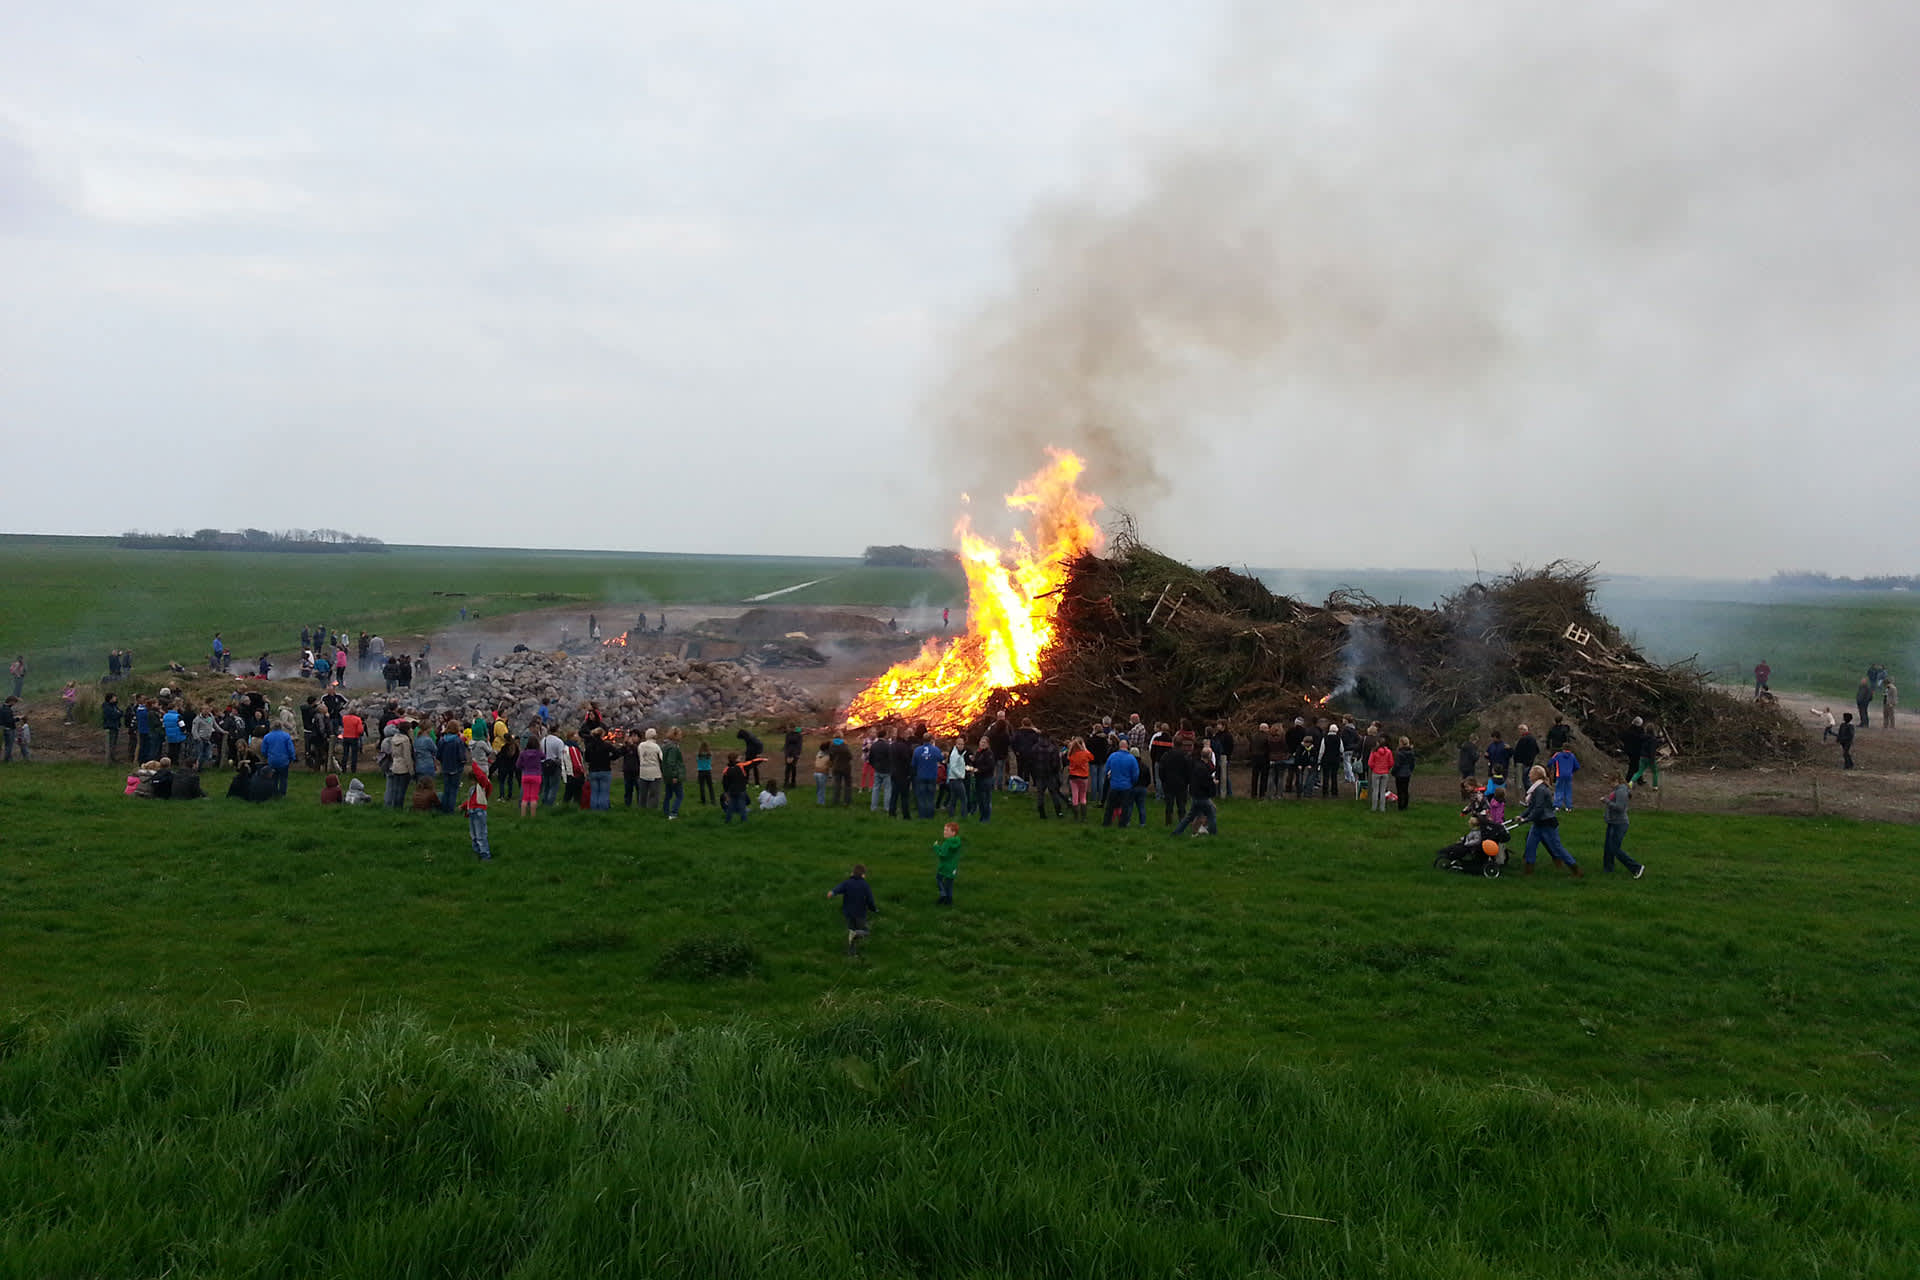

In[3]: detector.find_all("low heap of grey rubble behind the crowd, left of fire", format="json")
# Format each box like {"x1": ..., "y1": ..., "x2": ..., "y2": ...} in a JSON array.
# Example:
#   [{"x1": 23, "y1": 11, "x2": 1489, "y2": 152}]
[{"x1": 357, "y1": 645, "x2": 831, "y2": 729}]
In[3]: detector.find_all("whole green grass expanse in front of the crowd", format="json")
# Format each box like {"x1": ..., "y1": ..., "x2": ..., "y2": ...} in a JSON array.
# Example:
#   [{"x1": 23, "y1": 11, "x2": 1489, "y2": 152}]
[{"x1": 0, "y1": 764, "x2": 1920, "y2": 1276}]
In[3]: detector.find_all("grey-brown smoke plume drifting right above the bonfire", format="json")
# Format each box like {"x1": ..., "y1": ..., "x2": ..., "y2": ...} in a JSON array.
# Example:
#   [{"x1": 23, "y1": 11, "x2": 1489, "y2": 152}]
[{"x1": 929, "y1": 0, "x2": 1920, "y2": 574}]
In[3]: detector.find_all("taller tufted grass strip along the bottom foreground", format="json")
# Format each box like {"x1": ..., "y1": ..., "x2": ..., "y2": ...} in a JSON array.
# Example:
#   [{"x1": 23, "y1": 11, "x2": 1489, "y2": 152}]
[{"x1": 0, "y1": 1009, "x2": 1920, "y2": 1280}]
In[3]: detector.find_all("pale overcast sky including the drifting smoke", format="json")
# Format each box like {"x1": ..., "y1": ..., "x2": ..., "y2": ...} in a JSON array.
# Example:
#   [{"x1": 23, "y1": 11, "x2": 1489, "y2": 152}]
[{"x1": 0, "y1": 0, "x2": 1920, "y2": 576}]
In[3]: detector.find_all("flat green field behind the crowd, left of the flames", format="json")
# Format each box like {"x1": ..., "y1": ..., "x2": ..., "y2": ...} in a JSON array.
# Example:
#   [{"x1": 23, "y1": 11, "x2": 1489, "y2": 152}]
[{"x1": 0, "y1": 535, "x2": 966, "y2": 691}]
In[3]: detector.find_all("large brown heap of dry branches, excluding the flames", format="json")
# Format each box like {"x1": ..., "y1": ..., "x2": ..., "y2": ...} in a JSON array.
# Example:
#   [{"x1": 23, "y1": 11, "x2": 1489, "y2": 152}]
[{"x1": 1012, "y1": 528, "x2": 1807, "y2": 764}]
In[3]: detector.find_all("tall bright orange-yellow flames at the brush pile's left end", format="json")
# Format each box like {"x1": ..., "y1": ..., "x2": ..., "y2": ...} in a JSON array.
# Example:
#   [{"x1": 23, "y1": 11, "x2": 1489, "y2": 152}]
[{"x1": 847, "y1": 449, "x2": 1104, "y2": 733}]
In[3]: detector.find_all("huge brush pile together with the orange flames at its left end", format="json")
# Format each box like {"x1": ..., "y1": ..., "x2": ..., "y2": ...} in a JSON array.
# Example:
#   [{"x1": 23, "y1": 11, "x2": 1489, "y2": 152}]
[{"x1": 849, "y1": 455, "x2": 1807, "y2": 764}]
